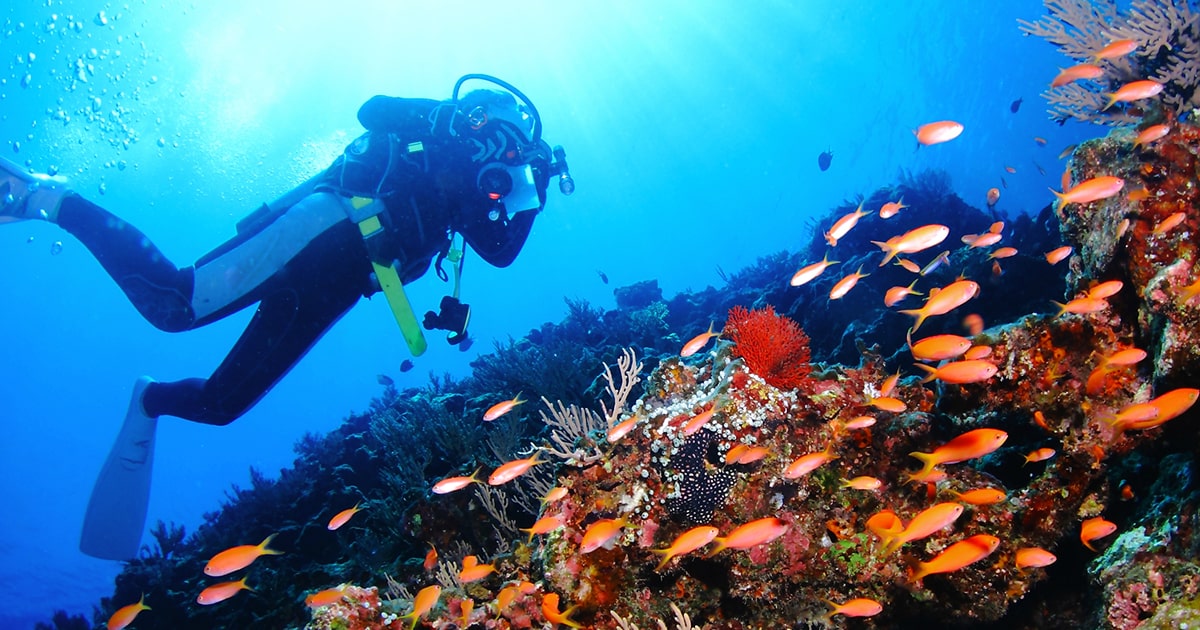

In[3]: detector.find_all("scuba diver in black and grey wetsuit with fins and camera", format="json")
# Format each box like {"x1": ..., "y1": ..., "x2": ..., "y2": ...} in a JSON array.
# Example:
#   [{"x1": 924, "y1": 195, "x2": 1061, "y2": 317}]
[{"x1": 0, "y1": 74, "x2": 575, "y2": 560}]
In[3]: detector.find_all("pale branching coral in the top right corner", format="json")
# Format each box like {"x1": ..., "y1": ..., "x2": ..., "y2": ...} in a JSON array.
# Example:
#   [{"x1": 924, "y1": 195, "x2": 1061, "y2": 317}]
[{"x1": 1018, "y1": 0, "x2": 1200, "y2": 125}]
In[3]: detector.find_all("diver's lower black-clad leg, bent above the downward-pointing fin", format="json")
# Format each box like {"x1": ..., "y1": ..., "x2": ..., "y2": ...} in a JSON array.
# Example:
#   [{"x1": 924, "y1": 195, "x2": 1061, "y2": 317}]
[{"x1": 143, "y1": 222, "x2": 371, "y2": 425}]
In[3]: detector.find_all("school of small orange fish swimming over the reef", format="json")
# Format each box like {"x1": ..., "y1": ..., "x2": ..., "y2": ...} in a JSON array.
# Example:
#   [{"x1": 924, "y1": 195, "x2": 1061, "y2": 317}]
[{"x1": 108, "y1": 40, "x2": 1200, "y2": 630}]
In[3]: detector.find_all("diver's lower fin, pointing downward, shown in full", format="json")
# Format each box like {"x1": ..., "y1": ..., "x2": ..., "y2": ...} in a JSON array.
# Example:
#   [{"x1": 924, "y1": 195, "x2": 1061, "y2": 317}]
[{"x1": 79, "y1": 377, "x2": 158, "y2": 560}]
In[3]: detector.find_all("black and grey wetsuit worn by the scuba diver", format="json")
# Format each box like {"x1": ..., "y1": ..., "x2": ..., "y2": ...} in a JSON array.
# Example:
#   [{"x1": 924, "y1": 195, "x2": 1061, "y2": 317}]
[{"x1": 58, "y1": 97, "x2": 544, "y2": 425}]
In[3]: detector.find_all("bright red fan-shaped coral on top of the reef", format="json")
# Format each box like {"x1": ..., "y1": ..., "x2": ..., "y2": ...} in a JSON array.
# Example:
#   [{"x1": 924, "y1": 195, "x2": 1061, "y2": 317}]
[{"x1": 724, "y1": 306, "x2": 812, "y2": 389}]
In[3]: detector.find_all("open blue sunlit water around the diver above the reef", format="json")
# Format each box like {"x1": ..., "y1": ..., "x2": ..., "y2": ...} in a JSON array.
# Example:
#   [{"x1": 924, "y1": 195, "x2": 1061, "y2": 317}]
[{"x1": 0, "y1": 0, "x2": 1103, "y2": 628}]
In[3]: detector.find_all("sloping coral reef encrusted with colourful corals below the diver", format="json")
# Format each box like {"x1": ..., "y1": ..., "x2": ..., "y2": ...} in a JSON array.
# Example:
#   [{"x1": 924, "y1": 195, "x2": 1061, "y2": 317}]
[{"x1": 68, "y1": 125, "x2": 1200, "y2": 629}]
